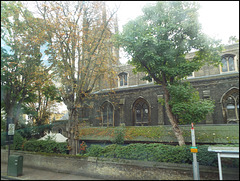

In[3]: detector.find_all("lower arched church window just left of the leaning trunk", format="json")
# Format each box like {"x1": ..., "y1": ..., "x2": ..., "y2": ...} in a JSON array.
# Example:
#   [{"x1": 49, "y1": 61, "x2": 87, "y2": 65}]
[{"x1": 133, "y1": 98, "x2": 150, "y2": 126}]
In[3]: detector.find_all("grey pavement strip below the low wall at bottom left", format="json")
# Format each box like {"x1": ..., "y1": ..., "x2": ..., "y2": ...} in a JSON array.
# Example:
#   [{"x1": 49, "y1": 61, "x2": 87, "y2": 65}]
[{"x1": 1, "y1": 162, "x2": 102, "y2": 180}]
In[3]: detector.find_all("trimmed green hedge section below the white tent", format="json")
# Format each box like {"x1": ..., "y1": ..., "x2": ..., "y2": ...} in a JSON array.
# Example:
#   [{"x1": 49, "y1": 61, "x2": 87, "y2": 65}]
[{"x1": 24, "y1": 140, "x2": 67, "y2": 153}]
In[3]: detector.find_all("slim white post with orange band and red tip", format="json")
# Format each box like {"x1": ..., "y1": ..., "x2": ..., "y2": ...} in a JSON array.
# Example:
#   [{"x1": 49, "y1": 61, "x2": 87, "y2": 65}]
[{"x1": 191, "y1": 123, "x2": 200, "y2": 180}]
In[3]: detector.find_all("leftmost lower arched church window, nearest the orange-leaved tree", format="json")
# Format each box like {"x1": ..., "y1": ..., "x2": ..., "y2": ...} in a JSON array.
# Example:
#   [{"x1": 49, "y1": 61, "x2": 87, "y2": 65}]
[{"x1": 101, "y1": 101, "x2": 114, "y2": 127}]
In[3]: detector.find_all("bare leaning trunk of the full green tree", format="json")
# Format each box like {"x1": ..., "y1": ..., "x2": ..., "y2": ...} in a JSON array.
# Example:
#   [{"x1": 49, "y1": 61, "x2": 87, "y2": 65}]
[{"x1": 162, "y1": 83, "x2": 185, "y2": 146}]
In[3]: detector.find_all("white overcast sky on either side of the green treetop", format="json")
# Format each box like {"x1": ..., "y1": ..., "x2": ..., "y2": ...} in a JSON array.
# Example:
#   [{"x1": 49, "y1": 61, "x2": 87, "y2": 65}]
[{"x1": 107, "y1": 1, "x2": 239, "y2": 63}]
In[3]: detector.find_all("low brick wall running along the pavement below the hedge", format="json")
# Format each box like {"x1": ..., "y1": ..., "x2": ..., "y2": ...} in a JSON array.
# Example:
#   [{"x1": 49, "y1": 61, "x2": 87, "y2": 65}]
[{"x1": 1, "y1": 149, "x2": 239, "y2": 180}]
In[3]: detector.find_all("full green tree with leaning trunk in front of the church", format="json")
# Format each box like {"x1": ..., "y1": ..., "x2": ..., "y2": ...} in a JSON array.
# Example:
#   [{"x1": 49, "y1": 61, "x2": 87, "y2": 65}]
[{"x1": 119, "y1": 1, "x2": 221, "y2": 145}]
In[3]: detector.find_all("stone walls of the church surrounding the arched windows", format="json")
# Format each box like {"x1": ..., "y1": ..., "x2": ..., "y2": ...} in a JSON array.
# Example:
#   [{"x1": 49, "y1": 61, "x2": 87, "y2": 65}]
[{"x1": 82, "y1": 44, "x2": 239, "y2": 126}]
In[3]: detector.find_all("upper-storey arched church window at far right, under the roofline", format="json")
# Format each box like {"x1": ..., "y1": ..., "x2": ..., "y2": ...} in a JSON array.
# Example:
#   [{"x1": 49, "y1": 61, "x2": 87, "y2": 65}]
[{"x1": 220, "y1": 54, "x2": 236, "y2": 73}]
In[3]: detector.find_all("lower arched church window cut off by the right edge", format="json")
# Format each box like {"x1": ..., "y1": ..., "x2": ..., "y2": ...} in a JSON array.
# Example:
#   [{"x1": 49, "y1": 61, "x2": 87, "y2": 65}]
[{"x1": 221, "y1": 88, "x2": 239, "y2": 123}]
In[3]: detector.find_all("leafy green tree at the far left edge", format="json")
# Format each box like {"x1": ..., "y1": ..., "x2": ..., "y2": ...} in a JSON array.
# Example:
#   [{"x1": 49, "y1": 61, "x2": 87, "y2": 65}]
[{"x1": 1, "y1": 2, "x2": 40, "y2": 127}]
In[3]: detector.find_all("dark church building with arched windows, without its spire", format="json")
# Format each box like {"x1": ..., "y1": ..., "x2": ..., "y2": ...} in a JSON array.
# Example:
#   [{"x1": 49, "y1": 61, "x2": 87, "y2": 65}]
[{"x1": 79, "y1": 44, "x2": 239, "y2": 127}]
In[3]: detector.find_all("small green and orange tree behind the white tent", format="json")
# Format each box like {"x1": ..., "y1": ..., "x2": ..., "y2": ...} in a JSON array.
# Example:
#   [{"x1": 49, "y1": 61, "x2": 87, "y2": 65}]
[{"x1": 23, "y1": 76, "x2": 61, "y2": 138}]
